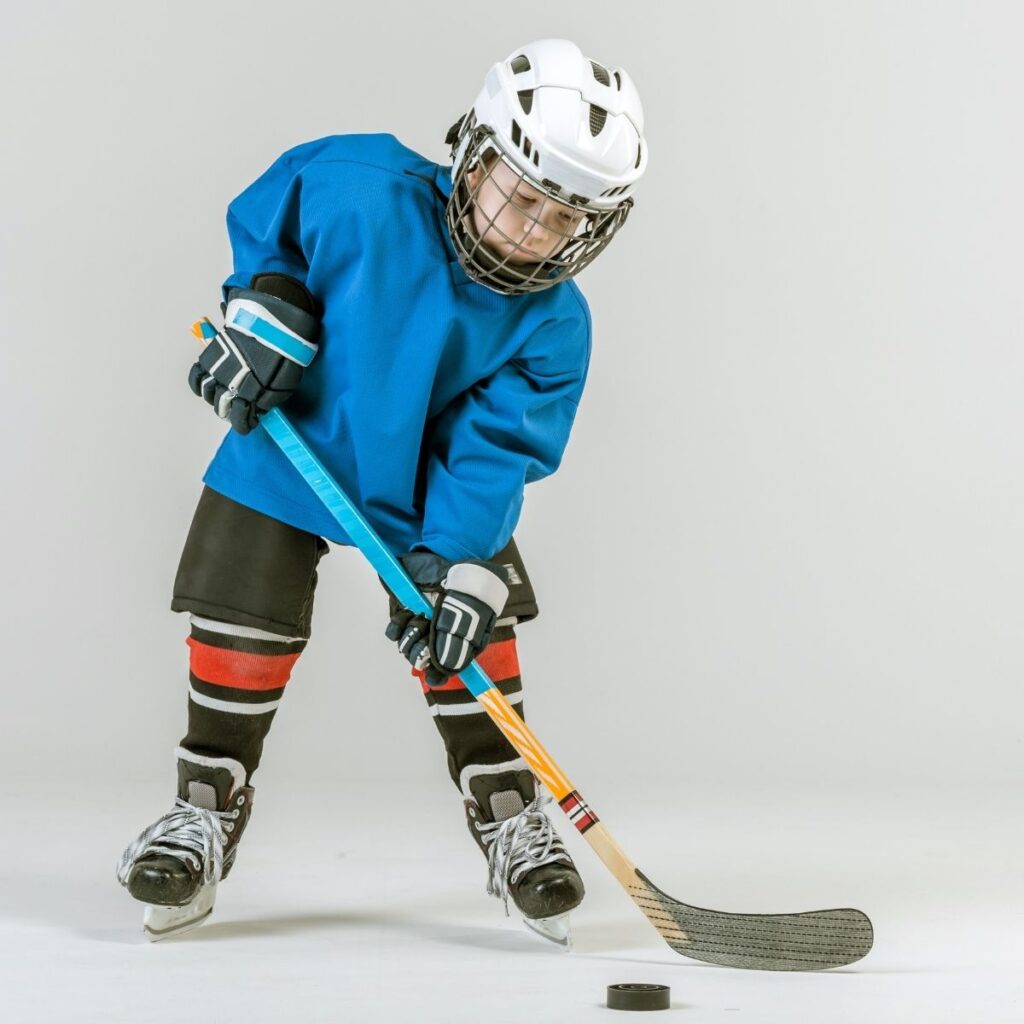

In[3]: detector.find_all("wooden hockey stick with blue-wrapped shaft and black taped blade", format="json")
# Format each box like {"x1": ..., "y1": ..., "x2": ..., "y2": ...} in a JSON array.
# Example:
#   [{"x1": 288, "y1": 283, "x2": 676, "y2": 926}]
[{"x1": 193, "y1": 321, "x2": 873, "y2": 971}]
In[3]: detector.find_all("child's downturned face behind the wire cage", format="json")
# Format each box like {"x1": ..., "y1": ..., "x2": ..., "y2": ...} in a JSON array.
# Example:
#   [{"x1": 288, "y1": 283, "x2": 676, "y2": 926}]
[{"x1": 466, "y1": 160, "x2": 586, "y2": 266}]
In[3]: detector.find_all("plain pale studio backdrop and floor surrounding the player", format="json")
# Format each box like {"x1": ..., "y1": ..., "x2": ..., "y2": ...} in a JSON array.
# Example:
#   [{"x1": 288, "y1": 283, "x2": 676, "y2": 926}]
[{"x1": 0, "y1": 0, "x2": 1024, "y2": 1021}]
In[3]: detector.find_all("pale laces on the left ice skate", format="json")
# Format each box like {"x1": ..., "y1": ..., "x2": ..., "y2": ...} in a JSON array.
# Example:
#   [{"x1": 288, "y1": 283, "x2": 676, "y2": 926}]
[{"x1": 118, "y1": 797, "x2": 239, "y2": 885}]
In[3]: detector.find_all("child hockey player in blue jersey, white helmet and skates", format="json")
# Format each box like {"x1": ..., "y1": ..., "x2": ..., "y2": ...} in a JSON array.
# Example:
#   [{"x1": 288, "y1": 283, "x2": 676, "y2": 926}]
[{"x1": 118, "y1": 39, "x2": 647, "y2": 941}]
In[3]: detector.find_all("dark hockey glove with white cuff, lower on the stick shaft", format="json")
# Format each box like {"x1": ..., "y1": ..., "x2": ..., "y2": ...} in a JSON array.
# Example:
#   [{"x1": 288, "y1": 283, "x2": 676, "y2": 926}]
[{"x1": 385, "y1": 551, "x2": 509, "y2": 686}]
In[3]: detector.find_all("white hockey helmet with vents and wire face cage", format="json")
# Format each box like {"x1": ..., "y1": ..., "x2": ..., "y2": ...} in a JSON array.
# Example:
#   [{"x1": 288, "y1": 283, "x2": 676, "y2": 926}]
[{"x1": 446, "y1": 39, "x2": 647, "y2": 295}]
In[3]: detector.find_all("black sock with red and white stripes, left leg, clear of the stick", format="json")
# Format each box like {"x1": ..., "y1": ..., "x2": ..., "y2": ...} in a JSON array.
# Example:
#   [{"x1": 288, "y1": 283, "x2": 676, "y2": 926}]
[{"x1": 181, "y1": 614, "x2": 306, "y2": 777}]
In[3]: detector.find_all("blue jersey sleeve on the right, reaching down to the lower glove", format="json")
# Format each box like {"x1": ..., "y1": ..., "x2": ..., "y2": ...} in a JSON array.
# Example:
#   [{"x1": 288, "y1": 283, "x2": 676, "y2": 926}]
[{"x1": 422, "y1": 307, "x2": 591, "y2": 560}]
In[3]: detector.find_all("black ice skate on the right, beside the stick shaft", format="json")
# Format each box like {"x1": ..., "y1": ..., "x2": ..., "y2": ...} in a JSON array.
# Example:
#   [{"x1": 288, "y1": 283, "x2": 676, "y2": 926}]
[{"x1": 466, "y1": 769, "x2": 584, "y2": 949}]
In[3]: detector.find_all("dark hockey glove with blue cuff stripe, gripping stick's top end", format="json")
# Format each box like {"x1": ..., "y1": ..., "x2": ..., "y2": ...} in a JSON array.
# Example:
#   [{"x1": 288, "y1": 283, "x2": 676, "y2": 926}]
[{"x1": 188, "y1": 273, "x2": 319, "y2": 434}]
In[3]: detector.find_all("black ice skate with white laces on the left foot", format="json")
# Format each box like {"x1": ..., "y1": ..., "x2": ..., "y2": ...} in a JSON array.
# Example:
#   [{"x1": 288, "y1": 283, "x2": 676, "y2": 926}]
[{"x1": 118, "y1": 746, "x2": 253, "y2": 942}]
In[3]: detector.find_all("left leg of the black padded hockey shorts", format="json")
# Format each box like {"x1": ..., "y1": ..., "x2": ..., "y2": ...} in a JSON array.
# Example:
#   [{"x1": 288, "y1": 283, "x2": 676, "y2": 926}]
[{"x1": 171, "y1": 487, "x2": 329, "y2": 638}]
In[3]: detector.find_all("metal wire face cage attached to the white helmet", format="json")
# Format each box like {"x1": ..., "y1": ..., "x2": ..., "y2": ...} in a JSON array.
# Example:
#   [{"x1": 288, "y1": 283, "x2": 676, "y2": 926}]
[{"x1": 445, "y1": 125, "x2": 633, "y2": 295}]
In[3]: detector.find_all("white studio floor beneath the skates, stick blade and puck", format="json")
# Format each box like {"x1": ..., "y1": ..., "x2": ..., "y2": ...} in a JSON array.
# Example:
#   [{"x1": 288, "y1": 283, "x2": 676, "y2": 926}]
[{"x1": 0, "y1": 779, "x2": 1024, "y2": 1024}]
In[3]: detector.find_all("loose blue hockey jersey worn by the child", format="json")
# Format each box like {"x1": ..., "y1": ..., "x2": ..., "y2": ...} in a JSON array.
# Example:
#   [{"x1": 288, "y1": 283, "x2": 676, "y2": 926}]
[{"x1": 204, "y1": 135, "x2": 591, "y2": 559}]
